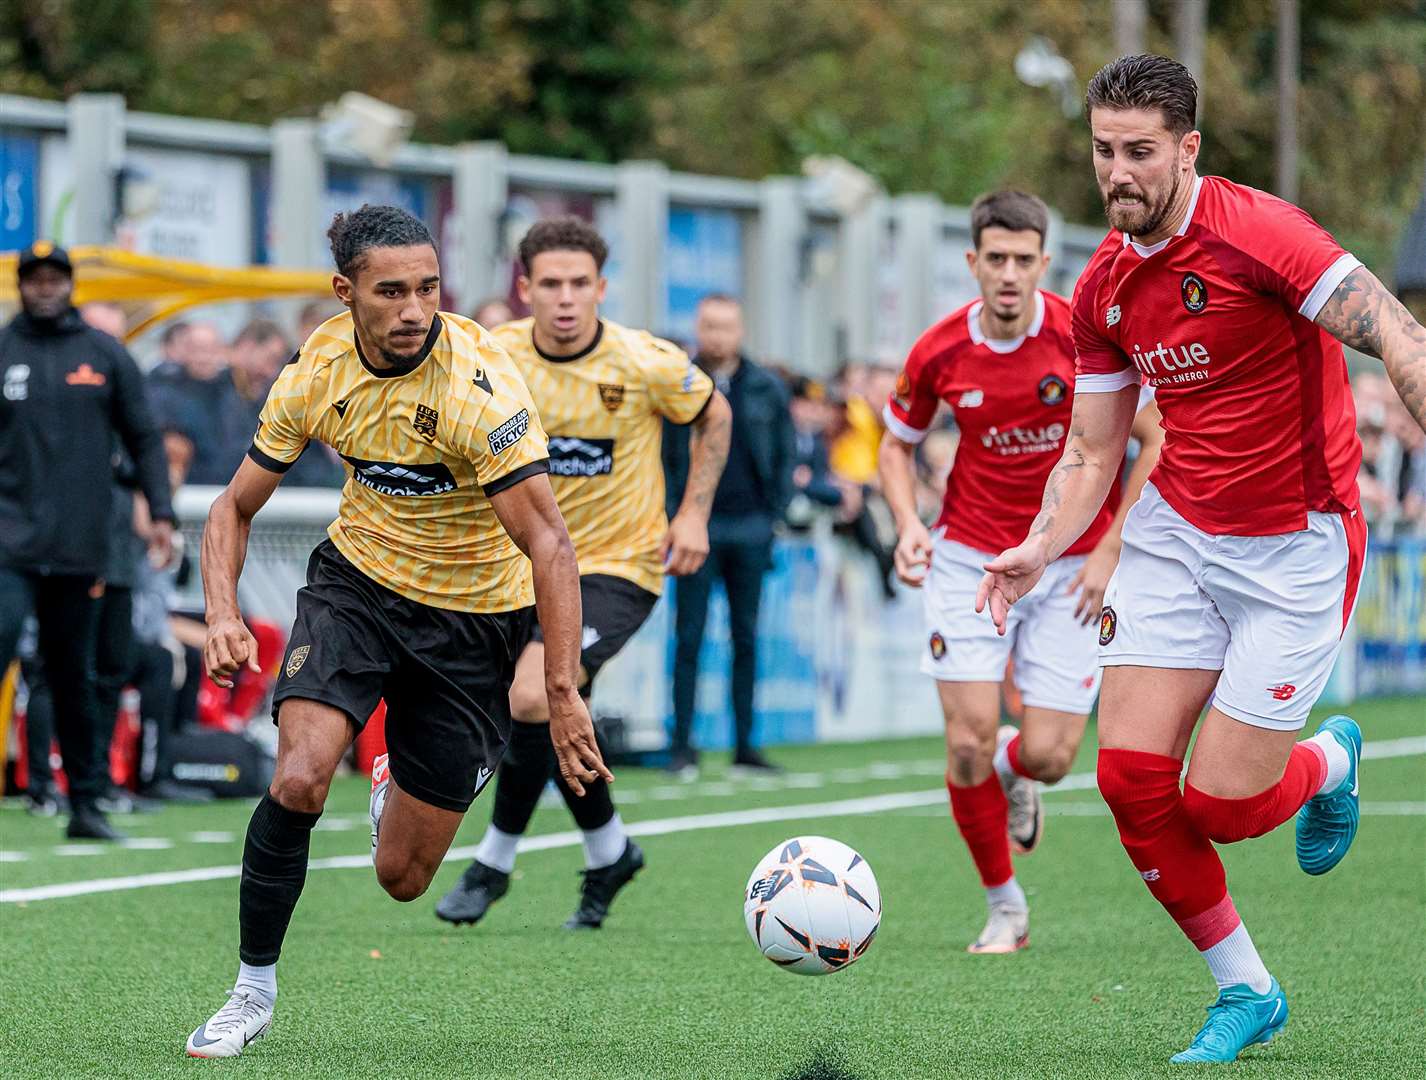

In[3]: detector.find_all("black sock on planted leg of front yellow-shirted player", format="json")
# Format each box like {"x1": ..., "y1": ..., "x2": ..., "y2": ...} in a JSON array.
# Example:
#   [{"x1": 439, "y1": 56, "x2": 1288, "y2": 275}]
[{"x1": 238, "y1": 792, "x2": 322, "y2": 964}]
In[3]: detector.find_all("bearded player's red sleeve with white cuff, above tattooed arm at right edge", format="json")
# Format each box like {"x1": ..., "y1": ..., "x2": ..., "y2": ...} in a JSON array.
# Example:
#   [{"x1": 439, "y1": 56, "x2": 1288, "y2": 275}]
[{"x1": 1208, "y1": 185, "x2": 1362, "y2": 320}]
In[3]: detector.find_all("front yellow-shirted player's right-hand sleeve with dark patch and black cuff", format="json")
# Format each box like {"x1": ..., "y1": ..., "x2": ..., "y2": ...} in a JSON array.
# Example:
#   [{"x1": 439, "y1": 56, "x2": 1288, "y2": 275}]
[{"x1": 453, "y1": 350, "x2": 549, "y2": 495}]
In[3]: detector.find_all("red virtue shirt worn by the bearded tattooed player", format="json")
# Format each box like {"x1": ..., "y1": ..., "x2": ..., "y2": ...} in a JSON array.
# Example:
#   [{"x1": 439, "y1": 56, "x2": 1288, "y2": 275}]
[{"x1": 1074, "y1": 177, "x2": 1362, "y2": 536}]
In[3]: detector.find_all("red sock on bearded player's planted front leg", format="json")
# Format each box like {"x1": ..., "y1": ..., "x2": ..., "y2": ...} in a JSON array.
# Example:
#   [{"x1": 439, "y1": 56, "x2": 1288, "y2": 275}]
[{"x1": 1098, "y1": 749, "x2": 1241, "y2": 952}]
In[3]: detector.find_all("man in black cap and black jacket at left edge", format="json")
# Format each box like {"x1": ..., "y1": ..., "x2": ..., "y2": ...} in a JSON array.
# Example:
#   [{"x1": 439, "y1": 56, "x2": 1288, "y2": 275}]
[{"x1": 0, "y1": 241, "x2": 174, "y2": 839}]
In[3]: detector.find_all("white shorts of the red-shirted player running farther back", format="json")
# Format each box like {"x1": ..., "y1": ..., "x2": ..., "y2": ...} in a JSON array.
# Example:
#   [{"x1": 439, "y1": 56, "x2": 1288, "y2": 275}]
[{"x1": 921, "y1": 536, "x2": 1099, "y2": 713}]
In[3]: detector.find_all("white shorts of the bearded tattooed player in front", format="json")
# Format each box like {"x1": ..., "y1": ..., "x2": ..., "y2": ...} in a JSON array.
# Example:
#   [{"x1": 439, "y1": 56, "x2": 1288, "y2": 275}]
[{"x1": 1099, "y1": 484, "x2": 1366, "y2": 730}]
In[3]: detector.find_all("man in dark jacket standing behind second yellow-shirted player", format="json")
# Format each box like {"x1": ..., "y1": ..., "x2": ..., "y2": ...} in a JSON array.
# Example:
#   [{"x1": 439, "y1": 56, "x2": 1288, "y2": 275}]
[{"x1": 663, "y1": 294, "x2": 796, "y2": 775}]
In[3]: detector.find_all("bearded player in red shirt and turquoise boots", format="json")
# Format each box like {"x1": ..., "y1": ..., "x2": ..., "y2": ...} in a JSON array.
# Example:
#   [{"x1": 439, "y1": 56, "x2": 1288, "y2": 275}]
[{"x1": 977, "y1": 56, "x2": 1426, "y2": 1061}]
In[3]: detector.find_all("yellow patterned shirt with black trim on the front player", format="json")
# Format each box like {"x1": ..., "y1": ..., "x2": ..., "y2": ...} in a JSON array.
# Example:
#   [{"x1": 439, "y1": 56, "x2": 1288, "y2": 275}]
[{"x1": 248, "y1": 312, "x2": 549, "y2": 612}]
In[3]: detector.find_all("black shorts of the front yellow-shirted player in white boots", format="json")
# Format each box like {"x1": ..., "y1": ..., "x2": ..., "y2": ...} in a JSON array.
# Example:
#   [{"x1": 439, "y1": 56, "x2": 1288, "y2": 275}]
[{"x1": 272, "y1": 539, "x2": 535, "y2": 813}]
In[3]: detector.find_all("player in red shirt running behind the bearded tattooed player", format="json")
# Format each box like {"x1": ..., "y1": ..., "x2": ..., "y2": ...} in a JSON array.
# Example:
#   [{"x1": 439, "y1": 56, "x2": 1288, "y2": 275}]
[{"x1": 881, "y1": 191, "x2": 1162, "y2": 953}]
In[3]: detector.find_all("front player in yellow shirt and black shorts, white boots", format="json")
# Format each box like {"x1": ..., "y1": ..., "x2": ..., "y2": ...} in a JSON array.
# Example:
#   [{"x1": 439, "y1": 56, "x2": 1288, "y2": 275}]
[{"x1": 188, "y1": 207, "x2": 613, "y2": 1057}]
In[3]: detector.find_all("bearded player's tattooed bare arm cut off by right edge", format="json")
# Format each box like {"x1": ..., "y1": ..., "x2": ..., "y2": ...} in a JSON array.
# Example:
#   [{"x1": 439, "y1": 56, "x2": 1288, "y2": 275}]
[{"x1": 1316, "y1": 267, "x2": 1426, "y2": 429}]
